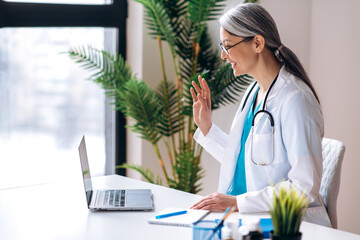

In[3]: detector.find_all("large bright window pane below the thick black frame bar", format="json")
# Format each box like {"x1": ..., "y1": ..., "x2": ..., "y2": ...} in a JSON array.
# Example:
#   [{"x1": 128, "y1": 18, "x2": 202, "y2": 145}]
[{"x1": 0, "y1": 28, "x2": 115, "y2": 189}]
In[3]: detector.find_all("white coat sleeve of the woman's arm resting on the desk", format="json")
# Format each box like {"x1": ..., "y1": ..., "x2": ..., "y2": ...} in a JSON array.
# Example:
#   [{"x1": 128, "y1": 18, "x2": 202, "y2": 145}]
[{"x1": 236, "y1": 91, "x2": 323, "y2": 213}]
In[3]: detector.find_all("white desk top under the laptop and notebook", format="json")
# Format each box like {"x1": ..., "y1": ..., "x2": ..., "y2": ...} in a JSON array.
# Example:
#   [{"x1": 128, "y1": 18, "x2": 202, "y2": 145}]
[{"x1": 0, "y1": 175, "x2": 360, "y2": 240}]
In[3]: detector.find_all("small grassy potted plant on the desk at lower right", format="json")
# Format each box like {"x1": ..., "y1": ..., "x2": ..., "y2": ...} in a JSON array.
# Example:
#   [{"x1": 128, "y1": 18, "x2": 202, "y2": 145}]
[{"x1": 270, "y1": 187, "x2": 308, "y2": 240}]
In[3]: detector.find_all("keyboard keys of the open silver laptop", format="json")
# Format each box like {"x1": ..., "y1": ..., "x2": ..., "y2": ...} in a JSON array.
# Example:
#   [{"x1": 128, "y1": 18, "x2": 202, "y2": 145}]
[{"x1": 96, "y1": 190, "x2": 125, "y2": 207}]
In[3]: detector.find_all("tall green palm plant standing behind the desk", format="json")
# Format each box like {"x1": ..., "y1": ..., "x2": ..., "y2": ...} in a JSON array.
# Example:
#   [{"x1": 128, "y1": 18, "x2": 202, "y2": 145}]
[{"x1": 68, "y1": 0, "x2": 253, "y2": 193}]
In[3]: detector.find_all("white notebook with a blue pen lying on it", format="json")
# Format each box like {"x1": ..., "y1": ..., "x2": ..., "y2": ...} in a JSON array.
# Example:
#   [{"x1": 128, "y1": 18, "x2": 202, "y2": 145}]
[{"x1": 148, "y1": 208, "x2": 210, "y2": 227}]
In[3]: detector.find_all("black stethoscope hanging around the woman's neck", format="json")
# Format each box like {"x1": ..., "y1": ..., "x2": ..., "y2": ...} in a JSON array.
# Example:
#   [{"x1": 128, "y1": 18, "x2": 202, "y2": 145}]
[{"x1": 241, "y1": 74, "x2": 279, "y2": 166}]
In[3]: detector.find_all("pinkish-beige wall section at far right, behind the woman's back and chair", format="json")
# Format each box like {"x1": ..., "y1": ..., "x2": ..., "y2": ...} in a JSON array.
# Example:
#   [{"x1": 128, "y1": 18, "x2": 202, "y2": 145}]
[{"x1": 308, "y1": 0, "x2": 360, "y2": 234}]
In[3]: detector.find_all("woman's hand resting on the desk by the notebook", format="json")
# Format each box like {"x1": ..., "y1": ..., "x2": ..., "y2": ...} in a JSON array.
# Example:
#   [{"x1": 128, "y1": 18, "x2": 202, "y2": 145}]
[{"x1": 190, "y1": 192, "x2": 238, "y2": 211}]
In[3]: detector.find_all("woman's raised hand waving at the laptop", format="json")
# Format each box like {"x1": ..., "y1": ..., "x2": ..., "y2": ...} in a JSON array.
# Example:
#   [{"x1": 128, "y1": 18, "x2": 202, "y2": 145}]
[{"x1": 190, "y1": 75, "x2": 211, "y2": 136}]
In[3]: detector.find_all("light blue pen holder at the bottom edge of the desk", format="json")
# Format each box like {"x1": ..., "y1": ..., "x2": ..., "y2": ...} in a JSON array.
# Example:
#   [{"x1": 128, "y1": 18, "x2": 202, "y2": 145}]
[{"x1": 192, "y1": 220, "x2": 221, "y2": 240}]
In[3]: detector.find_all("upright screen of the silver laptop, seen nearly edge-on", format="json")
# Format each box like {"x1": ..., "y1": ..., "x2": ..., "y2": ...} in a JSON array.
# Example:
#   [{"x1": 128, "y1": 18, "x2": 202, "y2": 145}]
[{"x1": 79, "y1": 136, "x2": 92, "y2": 206}]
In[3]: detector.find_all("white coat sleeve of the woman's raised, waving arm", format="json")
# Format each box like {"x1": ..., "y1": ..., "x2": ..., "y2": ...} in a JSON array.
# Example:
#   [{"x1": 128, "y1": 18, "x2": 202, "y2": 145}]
[{"x1": 194, "y1": 123, "x2": 228, "y2": 163}]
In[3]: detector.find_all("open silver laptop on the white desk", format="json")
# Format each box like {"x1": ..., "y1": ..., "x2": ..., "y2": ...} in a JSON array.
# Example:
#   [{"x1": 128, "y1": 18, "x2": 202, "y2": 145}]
[{"x1": 79, "y1": 136, "x2": 154, "y2": 211}]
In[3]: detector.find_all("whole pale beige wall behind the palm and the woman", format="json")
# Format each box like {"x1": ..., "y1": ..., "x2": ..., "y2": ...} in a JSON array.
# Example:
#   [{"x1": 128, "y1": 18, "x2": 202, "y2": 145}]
[{"x1": 127, "y1": 0, "x2": 360, "y2": 234}]
